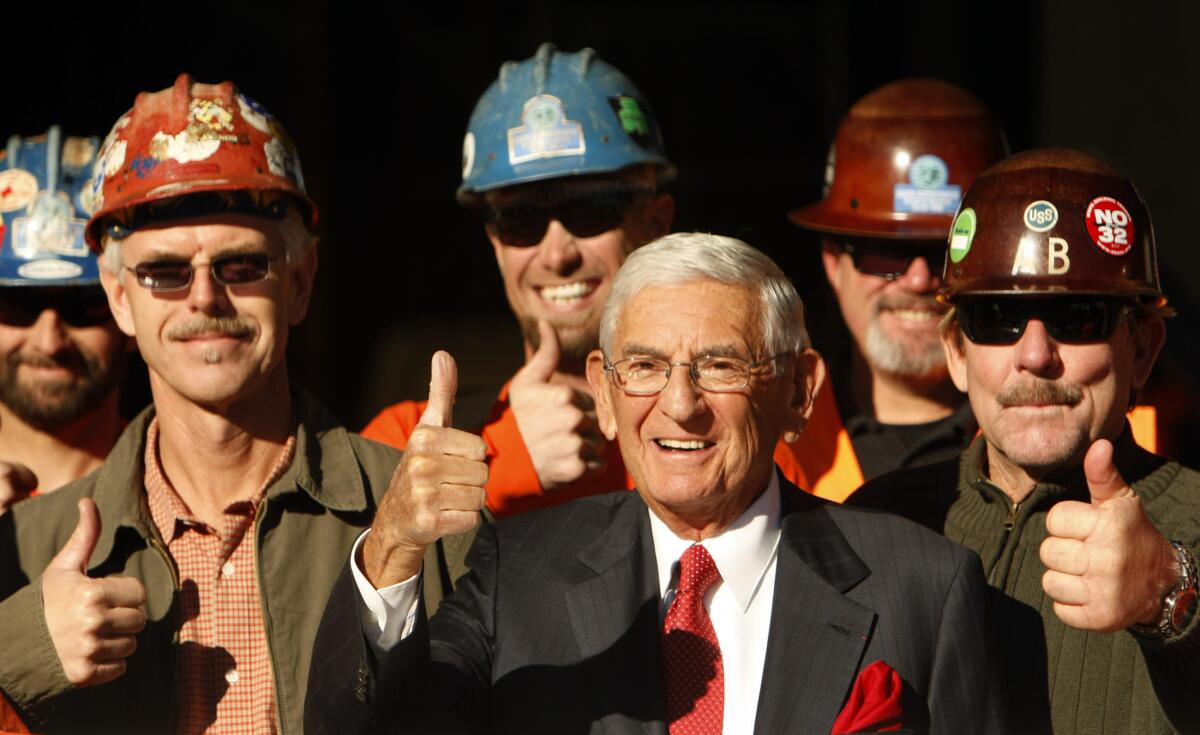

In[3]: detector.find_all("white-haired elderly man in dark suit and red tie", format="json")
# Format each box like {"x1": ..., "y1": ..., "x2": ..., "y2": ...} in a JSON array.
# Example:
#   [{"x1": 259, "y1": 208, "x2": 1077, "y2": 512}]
[{"x1": 306, "y1": 234, "x2": 1007, "y2": 734}]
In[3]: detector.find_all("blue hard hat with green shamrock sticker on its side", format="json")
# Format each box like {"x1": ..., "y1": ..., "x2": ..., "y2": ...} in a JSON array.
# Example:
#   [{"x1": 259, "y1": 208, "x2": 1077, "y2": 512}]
[{"x1": 457, "y1": 43, "x2": 676, "y2": 204}]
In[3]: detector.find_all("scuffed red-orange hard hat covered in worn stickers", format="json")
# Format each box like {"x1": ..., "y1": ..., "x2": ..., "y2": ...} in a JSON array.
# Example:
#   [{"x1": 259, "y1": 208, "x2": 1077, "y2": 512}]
[{"x1": 86, "y1": 73, "x2": 317, "y2": 252}]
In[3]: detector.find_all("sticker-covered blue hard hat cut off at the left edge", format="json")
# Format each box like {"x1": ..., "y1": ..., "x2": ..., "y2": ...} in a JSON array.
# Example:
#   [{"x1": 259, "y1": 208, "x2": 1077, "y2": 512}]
[{"x1": 0, "y1": 125, "x2": 100, "y2": 286}]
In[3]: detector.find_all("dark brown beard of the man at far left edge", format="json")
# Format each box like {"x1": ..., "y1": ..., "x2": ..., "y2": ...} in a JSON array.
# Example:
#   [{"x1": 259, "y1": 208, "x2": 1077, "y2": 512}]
[{"x1": 0, "y1": 345, "x2": 125, "y2": 434}]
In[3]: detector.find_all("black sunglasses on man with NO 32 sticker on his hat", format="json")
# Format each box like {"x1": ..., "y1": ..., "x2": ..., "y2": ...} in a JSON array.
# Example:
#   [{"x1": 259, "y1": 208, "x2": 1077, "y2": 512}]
[{"x1": 955, "y1": 297, "x2": 1133, "y2": 345}]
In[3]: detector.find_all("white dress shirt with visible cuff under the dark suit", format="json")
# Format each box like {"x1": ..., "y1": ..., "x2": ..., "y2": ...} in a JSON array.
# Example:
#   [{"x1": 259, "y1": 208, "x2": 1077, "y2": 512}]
[{"x1": 350, "y1": 472, "x2": 780, "y2": 733}]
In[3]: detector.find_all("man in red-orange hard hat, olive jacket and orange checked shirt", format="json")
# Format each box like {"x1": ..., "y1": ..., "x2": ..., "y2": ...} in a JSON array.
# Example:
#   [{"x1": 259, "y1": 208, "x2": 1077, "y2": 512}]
[{"x1": 0, "y1": 74, "x2": 436, "y2": 734}]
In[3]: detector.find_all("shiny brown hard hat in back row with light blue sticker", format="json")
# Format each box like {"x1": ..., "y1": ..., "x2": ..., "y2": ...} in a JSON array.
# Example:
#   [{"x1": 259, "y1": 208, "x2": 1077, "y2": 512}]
[{"x1": 788, "y1": 79, "x2": 1008, "y2": 240}]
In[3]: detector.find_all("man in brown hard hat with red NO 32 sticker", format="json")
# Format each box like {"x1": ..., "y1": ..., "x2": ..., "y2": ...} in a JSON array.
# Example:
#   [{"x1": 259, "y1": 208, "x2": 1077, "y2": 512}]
[{"x1": 847, "y1": 150, "x2": 1200, "y2": 733}]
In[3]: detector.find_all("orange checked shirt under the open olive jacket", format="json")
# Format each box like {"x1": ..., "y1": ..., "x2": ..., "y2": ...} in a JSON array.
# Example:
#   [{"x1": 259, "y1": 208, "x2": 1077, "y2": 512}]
[{"x1": 145, "y1": 418, "x2": 295, "y2": 735}]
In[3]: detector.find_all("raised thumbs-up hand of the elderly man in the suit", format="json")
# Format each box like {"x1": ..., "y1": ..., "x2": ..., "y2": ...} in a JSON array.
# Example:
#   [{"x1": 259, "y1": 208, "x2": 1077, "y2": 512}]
[{"x1": 362, "y1": 352, "x2": 487, "y2": 588}]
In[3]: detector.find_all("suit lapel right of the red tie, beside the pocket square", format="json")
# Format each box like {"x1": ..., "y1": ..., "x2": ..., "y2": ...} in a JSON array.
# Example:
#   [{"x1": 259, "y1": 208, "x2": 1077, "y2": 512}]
[{"x1": 755, "y1": 480, "x2": 876, "y2": 734}]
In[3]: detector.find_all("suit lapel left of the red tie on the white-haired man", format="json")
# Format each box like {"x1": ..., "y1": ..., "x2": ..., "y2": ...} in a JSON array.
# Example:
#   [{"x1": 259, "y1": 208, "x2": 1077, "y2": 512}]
[{"x1": 565, "y1": 492, "x2": 666, "y2": 735}]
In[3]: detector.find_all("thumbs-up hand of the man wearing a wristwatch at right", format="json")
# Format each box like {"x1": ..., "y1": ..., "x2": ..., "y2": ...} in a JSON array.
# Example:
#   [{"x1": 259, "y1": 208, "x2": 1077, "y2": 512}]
[{"x1": 1040, "y1": 440, "x2": 1180, "y2": 633}]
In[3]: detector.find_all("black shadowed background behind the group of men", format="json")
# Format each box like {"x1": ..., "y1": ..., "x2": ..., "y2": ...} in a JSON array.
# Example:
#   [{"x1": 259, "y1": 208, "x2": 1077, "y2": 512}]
[{"x1": 0, "y1": 0, "x2": 1200, "y2": 451}]
